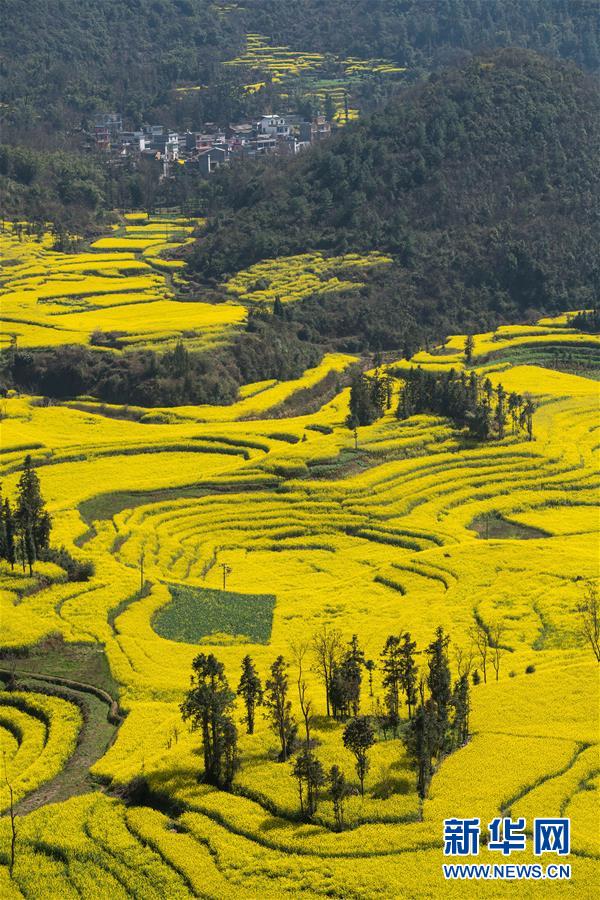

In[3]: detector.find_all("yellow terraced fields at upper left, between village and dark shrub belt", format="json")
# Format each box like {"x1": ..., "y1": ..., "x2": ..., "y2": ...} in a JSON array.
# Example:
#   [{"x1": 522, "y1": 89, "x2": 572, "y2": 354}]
[{"x1": 0, "y1": 218, "x2": 246, "y2": 349}]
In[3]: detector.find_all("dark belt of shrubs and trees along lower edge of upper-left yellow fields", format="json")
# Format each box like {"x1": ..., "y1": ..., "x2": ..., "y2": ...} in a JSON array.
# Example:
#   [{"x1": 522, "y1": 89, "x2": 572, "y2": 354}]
[{"x1": 1, "y1": 316, "x2": 322, "y2": 407}]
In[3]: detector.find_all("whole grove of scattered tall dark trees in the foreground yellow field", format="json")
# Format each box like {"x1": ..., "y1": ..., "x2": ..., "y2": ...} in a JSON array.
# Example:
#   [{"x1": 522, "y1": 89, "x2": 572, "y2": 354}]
[{"x1": 181, "y1": 626, "x2": 472, "y2": 830}]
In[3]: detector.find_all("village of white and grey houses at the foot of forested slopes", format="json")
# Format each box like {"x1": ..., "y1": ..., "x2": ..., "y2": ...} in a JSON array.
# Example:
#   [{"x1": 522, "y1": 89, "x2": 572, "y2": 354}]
[{"x1": 95, "y1": 113, "x2": 335, "y2": 178}]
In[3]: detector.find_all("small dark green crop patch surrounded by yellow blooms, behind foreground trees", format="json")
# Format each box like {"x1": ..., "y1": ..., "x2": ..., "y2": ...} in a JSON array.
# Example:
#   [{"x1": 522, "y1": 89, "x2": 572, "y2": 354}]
[{"x1": 152, "y1": 585, "x2": 275, "y2": 644}]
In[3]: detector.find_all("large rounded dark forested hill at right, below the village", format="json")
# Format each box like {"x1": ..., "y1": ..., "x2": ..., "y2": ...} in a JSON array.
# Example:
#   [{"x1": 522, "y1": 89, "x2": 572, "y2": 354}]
[{"x1": 192, "y1": 50, "x2": 600, "y2": 350}]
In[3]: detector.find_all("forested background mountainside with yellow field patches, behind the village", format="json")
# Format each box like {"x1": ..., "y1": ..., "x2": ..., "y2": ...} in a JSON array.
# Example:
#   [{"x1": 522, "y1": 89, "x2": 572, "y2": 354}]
[{"x1": 0, "y1": 0, "x2": 600, "y2": 241}]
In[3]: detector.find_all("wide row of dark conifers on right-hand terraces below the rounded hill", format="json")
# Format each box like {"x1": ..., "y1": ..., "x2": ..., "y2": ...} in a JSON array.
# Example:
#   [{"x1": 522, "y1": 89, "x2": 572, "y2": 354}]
[{"x1": 397, "y1": 366, "x2": 535, "y2": 441}]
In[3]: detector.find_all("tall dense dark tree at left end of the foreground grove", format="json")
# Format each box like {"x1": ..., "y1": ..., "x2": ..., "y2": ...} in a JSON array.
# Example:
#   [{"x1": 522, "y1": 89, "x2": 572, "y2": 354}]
[{"x1": 180, "y1": 653, "x2": 238, "y2": 788}]
